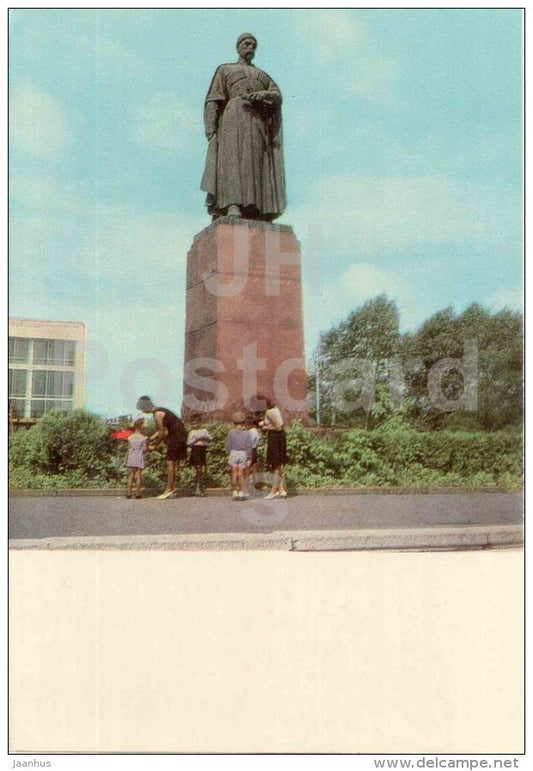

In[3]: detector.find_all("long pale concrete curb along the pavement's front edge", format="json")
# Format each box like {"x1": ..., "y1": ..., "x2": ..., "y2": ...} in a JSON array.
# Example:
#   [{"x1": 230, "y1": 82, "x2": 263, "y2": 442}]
[{"x1": 9, "y1": 525, "x2": 524, "y2": 552}]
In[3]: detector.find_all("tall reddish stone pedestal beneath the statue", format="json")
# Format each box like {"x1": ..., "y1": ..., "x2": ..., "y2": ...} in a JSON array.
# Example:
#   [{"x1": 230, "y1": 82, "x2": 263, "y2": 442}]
[{"x1": 182, "y1": 217, "x2": 308, "y2": 422}]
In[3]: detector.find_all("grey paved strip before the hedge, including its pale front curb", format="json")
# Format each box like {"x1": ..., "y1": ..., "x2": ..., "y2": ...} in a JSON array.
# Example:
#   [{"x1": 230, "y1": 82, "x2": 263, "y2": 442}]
[{"x1": 9, "y1": 492, "x2": 523, "y2": 551}]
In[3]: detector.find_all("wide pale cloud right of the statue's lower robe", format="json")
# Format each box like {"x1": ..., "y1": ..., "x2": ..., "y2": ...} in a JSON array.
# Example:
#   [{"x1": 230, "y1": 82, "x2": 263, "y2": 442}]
[{"x1": 293, "y1": 176, "x2": 517, "y2": 255}]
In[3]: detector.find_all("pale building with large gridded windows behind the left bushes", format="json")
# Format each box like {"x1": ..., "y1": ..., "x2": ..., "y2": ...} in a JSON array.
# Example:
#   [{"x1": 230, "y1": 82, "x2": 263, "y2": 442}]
[{"x1": 9, "y1": 319, "x2": 87, "y2": 423}]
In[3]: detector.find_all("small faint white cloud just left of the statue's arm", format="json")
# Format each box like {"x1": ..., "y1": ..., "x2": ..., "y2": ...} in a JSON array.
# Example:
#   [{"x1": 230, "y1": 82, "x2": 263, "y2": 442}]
[{"x1": 130, "y1": 92, "x2": 202, "y2": 151}]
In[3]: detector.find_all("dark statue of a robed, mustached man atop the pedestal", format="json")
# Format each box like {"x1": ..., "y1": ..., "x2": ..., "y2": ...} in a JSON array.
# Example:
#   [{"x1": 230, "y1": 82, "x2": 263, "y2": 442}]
[{"x1": 201, "y1": 32, "x2": 285, "y2": 222}]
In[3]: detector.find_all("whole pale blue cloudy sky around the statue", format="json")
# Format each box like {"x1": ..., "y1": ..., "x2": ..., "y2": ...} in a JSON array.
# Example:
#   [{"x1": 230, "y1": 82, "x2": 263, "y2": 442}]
[{"x1": 9, "y1": 9, "x2": 523, "y2": 415}]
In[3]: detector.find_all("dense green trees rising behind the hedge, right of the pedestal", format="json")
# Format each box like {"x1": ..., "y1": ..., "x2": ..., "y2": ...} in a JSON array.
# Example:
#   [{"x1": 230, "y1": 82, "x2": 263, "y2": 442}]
[{"x1": 310, "y1": 295, "x2": 523, "y2": 431}]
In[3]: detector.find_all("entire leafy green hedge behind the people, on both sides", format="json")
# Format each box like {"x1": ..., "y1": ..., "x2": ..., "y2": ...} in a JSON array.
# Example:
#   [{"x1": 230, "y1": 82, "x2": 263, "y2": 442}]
[{"x1": 9, "y1": 410, "x2": 522, "y2": 491}]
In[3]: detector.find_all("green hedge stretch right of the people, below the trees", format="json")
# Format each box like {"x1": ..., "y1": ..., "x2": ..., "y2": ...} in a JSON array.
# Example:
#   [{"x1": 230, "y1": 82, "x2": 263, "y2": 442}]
[{"x1": 282, "y1": 426, "x2": 522, "y2": 488}]
